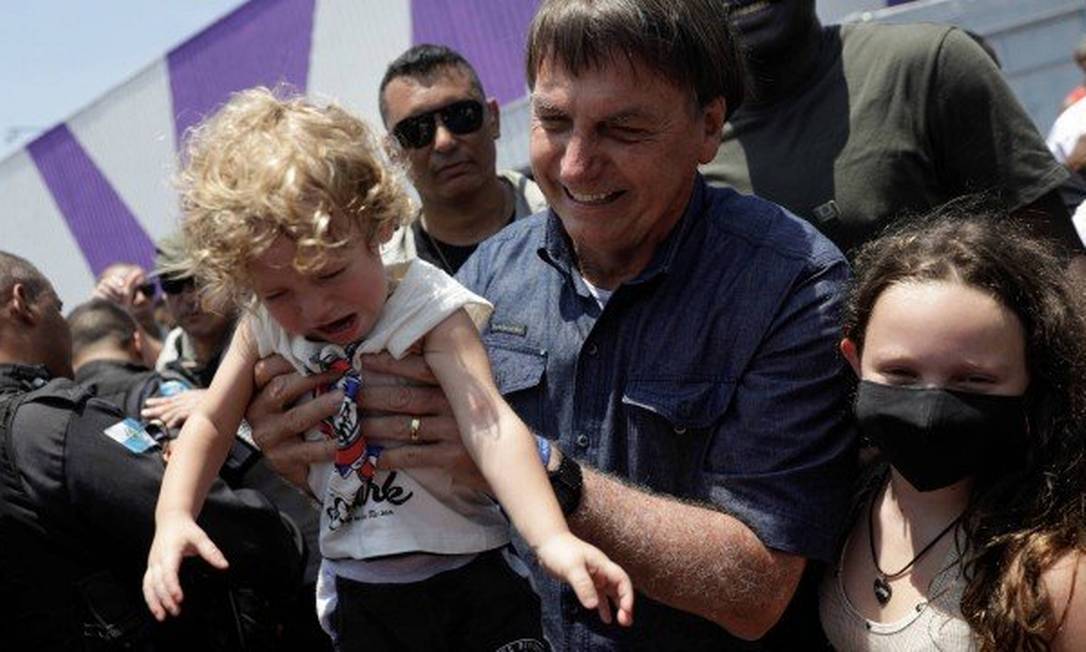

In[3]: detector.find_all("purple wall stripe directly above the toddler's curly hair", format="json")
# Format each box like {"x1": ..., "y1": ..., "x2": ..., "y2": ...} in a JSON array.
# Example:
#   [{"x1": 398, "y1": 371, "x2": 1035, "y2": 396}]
[{"x1": 166, "y1": 0, "x2": 315, "y2": 143}]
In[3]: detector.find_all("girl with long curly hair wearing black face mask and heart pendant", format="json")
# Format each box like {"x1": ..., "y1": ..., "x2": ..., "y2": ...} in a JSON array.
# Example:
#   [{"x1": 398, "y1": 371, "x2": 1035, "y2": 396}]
[{"x1": 820, "y1": 206, "x2": 1086, "y2": 651}]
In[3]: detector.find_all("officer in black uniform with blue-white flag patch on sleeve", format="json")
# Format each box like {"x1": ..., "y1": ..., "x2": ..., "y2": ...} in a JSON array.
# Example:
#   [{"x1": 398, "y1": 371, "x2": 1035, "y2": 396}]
[{"x1": 0, "y1": 252, "x2": 302, "y2": 652}]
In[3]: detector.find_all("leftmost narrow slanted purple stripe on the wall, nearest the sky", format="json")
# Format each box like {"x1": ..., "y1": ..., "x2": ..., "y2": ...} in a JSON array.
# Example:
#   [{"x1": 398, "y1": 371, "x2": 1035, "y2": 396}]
[{"x1": 27, "y1": 124, "x2": 154, "y2": 276}]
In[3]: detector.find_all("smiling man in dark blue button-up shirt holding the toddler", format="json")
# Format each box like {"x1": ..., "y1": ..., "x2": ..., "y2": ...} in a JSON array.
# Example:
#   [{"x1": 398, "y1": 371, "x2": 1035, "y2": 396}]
[{"x1": 445, "y1": 0, "x2": 853, "y2": 650}]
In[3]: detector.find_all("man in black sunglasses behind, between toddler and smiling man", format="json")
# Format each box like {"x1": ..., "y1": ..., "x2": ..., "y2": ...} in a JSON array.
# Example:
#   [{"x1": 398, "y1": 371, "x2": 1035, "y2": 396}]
[{"x1": 380, "y1": 45, "x2": 546, "y2": 274}]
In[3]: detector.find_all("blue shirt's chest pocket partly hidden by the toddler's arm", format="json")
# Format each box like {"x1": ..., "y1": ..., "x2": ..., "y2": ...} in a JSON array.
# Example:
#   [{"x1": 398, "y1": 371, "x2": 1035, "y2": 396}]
[{"x1": 483, "y1": 338, "x2": 546, "y2": 431}]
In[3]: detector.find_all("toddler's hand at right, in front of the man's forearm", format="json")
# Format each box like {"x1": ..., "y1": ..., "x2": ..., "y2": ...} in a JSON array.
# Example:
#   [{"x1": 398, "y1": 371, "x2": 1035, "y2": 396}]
[{"x1": 535, "y1": 532, "x2": 633, "y2": 627}]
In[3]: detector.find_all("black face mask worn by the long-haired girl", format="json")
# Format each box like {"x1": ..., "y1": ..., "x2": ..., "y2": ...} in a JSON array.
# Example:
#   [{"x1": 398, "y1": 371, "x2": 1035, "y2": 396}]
[{"x1": 856, "y1": 380, "x2": 1025, "y2": 491}]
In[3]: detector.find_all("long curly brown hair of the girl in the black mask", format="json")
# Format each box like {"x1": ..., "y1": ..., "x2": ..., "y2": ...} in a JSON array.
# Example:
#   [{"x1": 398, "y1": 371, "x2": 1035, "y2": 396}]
[{"x1": 844, "y1": 198, "x2": 1086, "y2": 651}]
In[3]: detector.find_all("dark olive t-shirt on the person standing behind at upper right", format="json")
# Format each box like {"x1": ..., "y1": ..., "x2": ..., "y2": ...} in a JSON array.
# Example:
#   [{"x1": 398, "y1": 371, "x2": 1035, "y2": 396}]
[{"x1": 703, "y1": 24, "x2": 1068, "y2": 253}]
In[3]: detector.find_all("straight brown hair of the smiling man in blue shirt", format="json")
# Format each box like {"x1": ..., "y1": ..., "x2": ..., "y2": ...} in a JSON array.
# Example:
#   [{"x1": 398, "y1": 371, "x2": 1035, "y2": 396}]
[{"x1": 526, "y1": 0, "x2": 746, "y2": 115}]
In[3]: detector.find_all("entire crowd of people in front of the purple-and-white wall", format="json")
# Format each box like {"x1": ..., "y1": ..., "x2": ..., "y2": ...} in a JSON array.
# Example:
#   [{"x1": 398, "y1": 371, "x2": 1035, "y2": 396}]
[{"x1": 0, "y1": 0, "x2": 1086, "y2": 651}]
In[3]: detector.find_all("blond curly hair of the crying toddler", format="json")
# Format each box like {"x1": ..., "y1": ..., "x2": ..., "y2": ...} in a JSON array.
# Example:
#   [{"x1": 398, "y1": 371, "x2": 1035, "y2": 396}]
[{"x1": 176, "y1": 87, "x2": 413, "y2": 304}]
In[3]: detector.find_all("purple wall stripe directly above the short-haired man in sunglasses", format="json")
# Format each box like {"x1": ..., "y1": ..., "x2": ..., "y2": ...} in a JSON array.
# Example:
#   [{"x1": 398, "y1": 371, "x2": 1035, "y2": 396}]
[{"x1": 411, "y1": 0, "x2": 539, "y2": 104}]
